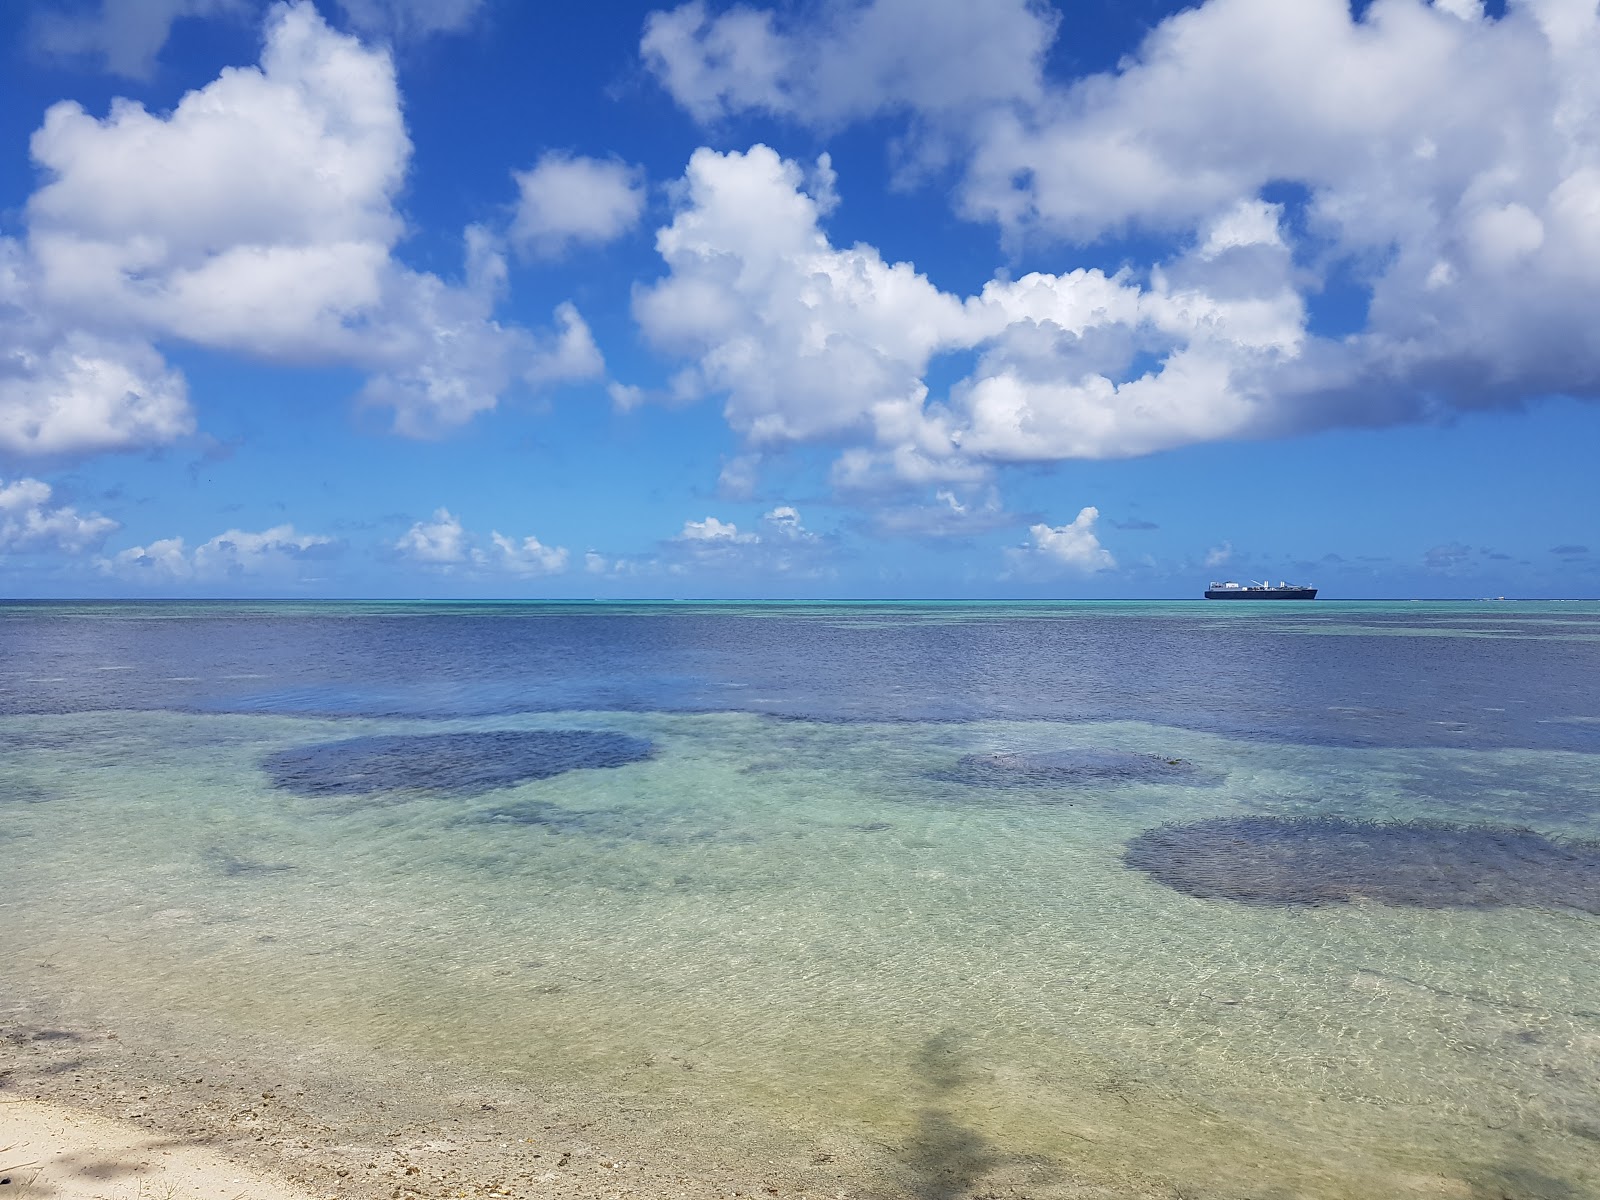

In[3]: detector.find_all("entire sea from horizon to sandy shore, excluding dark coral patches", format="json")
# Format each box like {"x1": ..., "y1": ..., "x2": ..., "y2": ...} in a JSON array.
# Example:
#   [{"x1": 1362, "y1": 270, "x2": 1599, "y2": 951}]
[{"x1": 0, "y1": 603, "x2": 1600, "y2": 1197}]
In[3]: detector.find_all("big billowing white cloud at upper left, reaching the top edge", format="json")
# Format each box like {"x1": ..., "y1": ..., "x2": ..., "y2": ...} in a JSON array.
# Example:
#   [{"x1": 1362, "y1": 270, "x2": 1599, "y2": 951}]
[{"x1": 27, "y1": 5, "x2": 411, "y2": 360}]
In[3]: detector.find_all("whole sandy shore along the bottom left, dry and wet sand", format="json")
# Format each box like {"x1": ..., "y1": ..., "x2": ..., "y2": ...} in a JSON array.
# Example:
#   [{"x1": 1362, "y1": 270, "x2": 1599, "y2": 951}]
[{"x1": 0, "y1": 1005, "x2": 1075, "y2": 1200}]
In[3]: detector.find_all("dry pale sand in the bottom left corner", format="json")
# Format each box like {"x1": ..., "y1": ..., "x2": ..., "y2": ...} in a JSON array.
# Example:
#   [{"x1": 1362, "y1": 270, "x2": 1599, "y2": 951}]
[{"x1": 0, "y1": 1099, "x2": 310, "y2": 1200}]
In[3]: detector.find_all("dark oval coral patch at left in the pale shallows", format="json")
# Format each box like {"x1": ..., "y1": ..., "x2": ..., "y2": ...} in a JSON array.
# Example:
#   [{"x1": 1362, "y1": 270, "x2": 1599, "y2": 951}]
[{"x1": 261, "y1": 730, "x2": 654, "y2": 795}]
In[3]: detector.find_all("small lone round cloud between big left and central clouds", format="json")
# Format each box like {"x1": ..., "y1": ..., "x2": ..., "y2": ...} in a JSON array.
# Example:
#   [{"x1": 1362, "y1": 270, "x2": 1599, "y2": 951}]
[{"x1": 510, "y1": 152, "x2": 645, "y2": 258}]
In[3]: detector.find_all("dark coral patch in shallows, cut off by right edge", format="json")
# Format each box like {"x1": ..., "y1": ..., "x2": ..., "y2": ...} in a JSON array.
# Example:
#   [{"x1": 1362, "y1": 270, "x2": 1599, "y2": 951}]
[{"x1": 1123, "y1": 816, "x2": 1600, "y2": 914}]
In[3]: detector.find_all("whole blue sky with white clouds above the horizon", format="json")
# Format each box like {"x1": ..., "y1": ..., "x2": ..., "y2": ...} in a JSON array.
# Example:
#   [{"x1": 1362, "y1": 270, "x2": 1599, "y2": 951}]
[{"x1": 0, "y1": 0, "x2": 1600, "y2": 598}]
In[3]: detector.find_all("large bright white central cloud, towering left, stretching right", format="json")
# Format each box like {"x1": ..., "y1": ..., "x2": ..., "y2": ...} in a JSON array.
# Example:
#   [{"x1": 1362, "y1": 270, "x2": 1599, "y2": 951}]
[{"x1": 634, "y1": 146, "x2": 1304, "y2": 490}]
